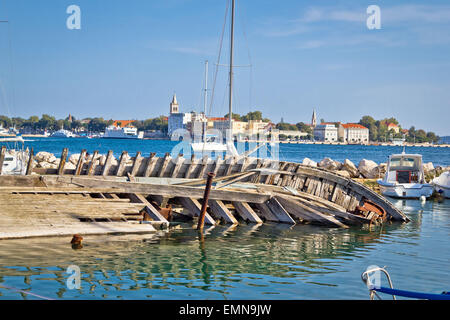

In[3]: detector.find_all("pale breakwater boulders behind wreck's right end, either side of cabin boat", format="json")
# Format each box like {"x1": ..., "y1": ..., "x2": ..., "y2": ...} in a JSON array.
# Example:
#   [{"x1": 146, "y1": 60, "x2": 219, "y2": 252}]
[{"x1": 303, "y1": 158, "x2": 450, "y2": 181}]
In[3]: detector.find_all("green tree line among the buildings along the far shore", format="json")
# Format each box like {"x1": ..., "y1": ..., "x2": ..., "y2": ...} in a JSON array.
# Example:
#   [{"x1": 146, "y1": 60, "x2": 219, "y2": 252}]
[{"x1": 0, "y1": 111, "x2": 439, "y2": 143}]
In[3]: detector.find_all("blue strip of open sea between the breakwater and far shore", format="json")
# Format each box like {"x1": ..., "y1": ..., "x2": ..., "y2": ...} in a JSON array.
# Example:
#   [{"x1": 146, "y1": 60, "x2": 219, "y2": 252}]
[{"x1": 18, "y1": 138, "x2": 450, "y2": 166}]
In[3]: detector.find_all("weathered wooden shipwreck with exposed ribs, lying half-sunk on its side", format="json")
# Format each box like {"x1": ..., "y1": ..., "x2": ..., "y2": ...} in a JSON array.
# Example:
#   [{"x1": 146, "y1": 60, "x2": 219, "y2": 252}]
[{"x1": 0, "y1": 149, "x2": 409, "y2": 238}]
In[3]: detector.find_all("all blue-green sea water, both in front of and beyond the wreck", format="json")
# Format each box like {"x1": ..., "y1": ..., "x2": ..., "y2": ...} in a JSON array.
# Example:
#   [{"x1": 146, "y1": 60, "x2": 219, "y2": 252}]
[{"x1": 0, "y1": 139, "x2": 450, "y2": 299}]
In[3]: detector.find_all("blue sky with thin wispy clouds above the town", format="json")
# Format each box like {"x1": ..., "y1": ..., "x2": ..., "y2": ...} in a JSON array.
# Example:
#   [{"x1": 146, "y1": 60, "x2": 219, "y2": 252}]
[{"x1": 0, "y1": 0, "x2": 450, "y2": 135}]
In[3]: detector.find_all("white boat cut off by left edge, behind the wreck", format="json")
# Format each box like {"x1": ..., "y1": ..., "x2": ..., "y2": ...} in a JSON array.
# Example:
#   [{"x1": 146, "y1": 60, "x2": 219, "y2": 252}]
[{"x1": 0, "y1": 136, "x2": 29, "y2": 175}]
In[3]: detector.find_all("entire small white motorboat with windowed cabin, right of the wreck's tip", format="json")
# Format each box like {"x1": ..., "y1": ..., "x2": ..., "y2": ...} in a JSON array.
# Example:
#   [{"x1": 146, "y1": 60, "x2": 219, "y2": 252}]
[{"x1": 377, "y1": 153, "x2": 433, "y2": 198}]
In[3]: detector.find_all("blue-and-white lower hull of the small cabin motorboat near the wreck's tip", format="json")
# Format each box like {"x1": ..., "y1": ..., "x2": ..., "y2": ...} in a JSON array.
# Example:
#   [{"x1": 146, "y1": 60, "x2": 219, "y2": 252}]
[{"x1": 377, "y1": 180, "x2": 433, "y2": 199}]
